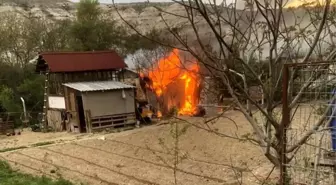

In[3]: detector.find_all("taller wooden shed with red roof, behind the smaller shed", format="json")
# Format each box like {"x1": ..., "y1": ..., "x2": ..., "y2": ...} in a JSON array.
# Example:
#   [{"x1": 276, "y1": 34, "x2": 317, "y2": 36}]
[{"x1": 36, "y1": 51, "x2": 127, "y2": 131}]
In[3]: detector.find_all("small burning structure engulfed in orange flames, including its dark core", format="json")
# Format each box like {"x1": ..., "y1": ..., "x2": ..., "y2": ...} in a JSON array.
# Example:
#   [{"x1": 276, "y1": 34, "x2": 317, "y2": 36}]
[{"x1": 141, "y1": 49, "x2": 201, "y2": 115}]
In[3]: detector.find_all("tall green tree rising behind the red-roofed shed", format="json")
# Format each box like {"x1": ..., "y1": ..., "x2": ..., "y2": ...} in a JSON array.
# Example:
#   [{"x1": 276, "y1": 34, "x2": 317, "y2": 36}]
[{"x1": 70, "y1": 0, "x2": 123, "y2": 51}]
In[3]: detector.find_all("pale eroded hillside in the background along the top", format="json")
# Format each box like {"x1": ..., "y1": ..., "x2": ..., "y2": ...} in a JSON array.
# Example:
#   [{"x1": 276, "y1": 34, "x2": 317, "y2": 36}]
[{"x1": 0, "y1": 0, "x2": 335, "y2": 58}]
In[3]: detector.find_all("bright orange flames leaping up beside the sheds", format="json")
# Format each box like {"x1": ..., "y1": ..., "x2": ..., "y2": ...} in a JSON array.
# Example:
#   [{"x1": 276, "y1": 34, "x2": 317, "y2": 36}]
[{"x1": 144, "y1": 49, "x2": 199, "y2": 115}]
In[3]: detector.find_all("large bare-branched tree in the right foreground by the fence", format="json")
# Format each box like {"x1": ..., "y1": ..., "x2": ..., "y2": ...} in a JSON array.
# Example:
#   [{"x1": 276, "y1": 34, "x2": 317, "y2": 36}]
[{"x1": 116, "y1": 0, "x2": 335, "y2": 171}]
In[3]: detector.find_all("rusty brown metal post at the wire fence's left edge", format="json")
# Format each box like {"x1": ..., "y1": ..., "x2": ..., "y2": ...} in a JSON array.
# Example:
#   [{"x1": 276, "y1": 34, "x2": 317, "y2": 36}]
[{"x1": 280, "y1": 64, "x2": 290, "y2": 185}]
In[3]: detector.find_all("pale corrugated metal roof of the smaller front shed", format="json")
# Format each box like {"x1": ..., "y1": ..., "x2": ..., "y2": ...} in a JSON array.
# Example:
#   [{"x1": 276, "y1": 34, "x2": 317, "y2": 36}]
[{"x1": 63, "y1": 81, "x2": 135, "y2": 92}]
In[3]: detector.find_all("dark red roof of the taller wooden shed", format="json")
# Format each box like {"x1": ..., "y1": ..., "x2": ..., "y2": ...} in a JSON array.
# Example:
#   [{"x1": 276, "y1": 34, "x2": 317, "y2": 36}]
[{"x1": 40, "y1": 51, "x2": 126, "y2": 73}]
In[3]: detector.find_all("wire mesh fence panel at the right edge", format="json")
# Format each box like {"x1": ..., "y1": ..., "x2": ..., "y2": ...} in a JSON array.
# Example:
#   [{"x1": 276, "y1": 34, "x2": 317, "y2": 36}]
[{"x1": 281, "y1": 62, "x2": 336, "y2": 185}]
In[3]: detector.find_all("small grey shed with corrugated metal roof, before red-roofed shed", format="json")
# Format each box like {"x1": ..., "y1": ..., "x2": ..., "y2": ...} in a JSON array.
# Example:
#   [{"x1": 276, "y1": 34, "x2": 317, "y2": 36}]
[{"x1": 63, "y1": 81, "x2": 136, "y2": 132}]
